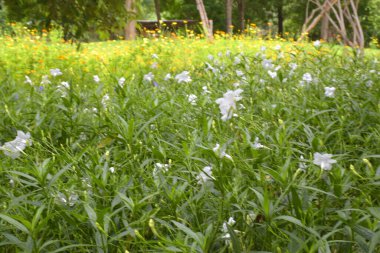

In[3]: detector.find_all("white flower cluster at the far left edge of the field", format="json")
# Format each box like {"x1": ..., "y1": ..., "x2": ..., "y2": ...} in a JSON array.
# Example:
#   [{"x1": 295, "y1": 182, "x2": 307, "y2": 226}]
[{"x1": 0, "y1": 131, "x2": 32, "y2": 159}]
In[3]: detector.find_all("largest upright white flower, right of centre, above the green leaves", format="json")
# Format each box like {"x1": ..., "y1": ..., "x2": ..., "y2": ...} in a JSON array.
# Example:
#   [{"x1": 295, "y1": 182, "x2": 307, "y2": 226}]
[{"x1": 215, "y1": 89, "x2": 243, "y2": 121}]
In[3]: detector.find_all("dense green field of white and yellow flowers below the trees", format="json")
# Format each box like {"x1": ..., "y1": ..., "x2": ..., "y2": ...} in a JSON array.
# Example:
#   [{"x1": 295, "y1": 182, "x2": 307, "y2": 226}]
[{"x1": 0, "y1": 39, "x2": 380, "y2": 253}]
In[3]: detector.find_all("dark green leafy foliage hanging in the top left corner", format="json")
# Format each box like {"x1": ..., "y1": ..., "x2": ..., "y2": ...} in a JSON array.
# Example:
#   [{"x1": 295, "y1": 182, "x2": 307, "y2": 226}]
[{"x1": 4, "y1": 0, "x2": 127, "y2": 40}]
